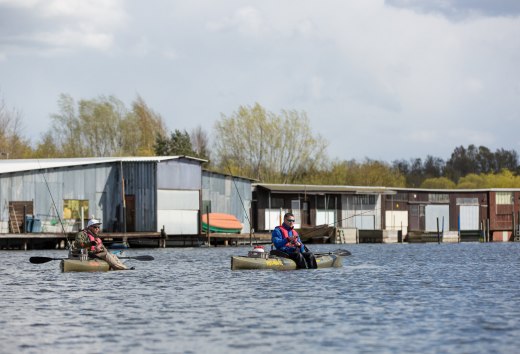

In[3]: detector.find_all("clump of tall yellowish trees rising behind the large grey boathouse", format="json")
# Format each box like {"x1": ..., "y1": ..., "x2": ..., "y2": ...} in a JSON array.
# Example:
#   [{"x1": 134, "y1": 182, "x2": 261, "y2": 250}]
[{"x1": 43, "y1": 94, "x2": 169, "y2": 157}]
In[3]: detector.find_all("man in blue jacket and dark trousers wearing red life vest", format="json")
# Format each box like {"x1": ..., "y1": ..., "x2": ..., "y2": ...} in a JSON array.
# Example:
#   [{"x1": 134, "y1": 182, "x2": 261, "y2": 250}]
[{"x1": 271, "y1": 213, "x2": 318, "y2": 269}]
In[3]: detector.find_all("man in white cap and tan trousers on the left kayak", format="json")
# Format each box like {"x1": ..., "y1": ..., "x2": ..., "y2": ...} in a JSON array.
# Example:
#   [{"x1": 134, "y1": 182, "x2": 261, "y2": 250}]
[{"x1": 73, "y1": 217, "x2": 128, "y2": 270}]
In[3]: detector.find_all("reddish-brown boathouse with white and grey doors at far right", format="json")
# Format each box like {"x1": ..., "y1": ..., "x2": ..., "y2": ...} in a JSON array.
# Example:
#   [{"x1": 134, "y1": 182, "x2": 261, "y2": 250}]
[{"x1": 384, "y1": 188, "x2": 520, "y2": 242}]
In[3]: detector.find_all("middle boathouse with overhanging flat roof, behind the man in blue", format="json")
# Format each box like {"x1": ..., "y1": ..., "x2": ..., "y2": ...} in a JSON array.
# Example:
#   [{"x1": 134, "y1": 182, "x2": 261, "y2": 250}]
[{"x1": 253, "y1": 183, "x2": 395, "y2": 242}]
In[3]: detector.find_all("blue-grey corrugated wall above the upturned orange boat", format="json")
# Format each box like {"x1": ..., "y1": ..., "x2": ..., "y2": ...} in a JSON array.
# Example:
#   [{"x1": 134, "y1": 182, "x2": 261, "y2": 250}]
[{"x1": 202, "y1": 171, "x2": 253, "y2": 233}]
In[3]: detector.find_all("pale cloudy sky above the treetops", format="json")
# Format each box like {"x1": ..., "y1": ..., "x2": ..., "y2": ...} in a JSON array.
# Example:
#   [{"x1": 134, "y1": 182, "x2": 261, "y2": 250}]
[{"x1": 0, "y1": 0, "x2": 520, "y2": 162}]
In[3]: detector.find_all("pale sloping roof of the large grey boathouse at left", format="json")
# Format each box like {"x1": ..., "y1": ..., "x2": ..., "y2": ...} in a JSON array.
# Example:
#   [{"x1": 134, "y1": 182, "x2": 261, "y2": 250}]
[{"x1": 0, "y1": 156, "x2": 206, "y2": 174}]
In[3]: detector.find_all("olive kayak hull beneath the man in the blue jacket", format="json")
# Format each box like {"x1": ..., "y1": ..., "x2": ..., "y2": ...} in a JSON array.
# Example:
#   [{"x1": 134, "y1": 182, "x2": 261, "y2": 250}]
[{"x1": 231, "y1": 254, "x2": 343, "y2": 270}]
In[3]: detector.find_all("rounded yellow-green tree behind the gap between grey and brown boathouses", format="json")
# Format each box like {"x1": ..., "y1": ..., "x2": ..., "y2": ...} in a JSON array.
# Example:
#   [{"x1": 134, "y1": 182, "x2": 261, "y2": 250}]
[{"x1": 215, "y1": 103, "x2": 327, "y2": 183}]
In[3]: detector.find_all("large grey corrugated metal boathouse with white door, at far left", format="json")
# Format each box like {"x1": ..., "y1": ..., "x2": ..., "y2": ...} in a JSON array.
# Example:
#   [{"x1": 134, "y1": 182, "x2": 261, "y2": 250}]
[{"x1": 0, "y1": 156, "x2": 205, "y2": 243}]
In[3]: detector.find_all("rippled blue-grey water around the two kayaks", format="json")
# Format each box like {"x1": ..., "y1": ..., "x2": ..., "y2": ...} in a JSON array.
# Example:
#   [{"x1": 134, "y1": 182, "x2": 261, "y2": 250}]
[{"x1": 0, "y1": 243, "x2": 520, "y2": 353}]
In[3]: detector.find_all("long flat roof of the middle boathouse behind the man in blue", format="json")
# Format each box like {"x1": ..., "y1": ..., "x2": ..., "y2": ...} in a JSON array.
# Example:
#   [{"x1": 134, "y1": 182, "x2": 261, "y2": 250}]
[{"x1": 252, "y1": 183, "x2": 396, "y2": 194}]
